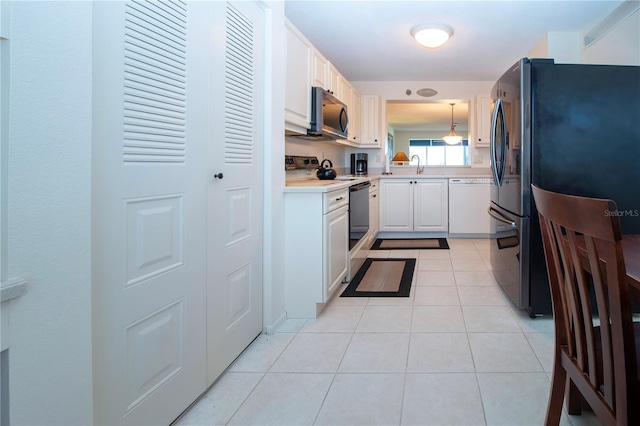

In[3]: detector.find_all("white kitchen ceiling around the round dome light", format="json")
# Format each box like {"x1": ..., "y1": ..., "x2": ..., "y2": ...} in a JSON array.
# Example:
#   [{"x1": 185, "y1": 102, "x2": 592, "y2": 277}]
[{"x1": 285, "y1": 0, "x2": 622, "y2": 81}]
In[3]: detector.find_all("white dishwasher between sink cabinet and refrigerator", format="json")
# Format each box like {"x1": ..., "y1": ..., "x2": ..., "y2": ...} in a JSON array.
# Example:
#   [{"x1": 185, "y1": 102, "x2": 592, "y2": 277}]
[{"x1": 449, "y1": 178, "x2": 491, "y2": 237}]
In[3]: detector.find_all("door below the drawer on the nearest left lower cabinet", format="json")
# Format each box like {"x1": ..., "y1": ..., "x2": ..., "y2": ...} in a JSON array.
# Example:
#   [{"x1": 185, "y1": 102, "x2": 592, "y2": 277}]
[{"x1": 322, "y1": 206, "x2": 349, "y2": 302}]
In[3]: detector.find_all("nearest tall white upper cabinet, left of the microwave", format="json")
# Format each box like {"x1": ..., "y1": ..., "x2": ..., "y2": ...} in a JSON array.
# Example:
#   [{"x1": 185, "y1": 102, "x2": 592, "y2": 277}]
[{"x1": 284, "y1": 21, "x2": 314, "y2": 134}]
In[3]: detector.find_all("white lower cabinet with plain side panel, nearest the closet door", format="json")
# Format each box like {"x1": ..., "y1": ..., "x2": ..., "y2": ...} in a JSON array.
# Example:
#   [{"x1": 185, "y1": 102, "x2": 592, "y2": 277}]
[{"x1": 285, "y1": 188, "x2": 349, "y2": 318}]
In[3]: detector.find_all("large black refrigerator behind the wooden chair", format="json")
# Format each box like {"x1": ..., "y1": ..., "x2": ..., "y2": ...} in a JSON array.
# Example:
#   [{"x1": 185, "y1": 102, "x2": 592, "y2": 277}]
[{"x1": 488, "y1": 58, "x2": 640, "y2": 317}]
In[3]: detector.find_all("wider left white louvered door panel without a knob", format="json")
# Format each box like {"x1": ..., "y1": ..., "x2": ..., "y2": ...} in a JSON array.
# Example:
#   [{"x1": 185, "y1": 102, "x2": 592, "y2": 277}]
[{"x1": 92, "y1": 0, "x2": 209, "y2": 425}]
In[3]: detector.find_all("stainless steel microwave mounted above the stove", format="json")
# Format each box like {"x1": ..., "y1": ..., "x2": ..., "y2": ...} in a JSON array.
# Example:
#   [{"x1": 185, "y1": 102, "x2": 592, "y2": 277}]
[{"x1": 307, "y1": 87, "x2": 349, "y2": 140}]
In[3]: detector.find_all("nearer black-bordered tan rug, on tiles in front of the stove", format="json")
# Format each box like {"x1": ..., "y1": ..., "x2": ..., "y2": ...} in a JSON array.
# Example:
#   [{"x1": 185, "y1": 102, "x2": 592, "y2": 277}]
[{"x1": 340, "y1": 258, "x2": 416, "y2": 297}]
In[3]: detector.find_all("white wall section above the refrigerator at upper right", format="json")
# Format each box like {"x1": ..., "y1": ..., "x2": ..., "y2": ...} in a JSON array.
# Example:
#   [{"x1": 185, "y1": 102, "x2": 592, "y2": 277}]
[{"x1": 582, "y1": 10, "x2": 640, "y2": 65}]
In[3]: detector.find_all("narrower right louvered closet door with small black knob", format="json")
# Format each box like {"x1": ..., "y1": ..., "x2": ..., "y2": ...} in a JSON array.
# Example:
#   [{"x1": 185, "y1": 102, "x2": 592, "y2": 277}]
[{"x1": 207, "y1": 2, "x2": 265, "y2": 383}]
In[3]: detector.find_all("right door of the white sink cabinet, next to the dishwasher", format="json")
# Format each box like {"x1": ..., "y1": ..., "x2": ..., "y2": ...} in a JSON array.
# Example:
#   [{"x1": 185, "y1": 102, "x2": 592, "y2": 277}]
[{"x1": 413, "y1": 179, "x2": 449, "y2": 232}]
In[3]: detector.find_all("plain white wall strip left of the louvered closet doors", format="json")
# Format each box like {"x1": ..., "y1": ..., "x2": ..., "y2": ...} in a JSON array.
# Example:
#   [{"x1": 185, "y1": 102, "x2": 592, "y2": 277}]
[{"x1": 7, "y1": 1, "x2": 93, "y2": 425}]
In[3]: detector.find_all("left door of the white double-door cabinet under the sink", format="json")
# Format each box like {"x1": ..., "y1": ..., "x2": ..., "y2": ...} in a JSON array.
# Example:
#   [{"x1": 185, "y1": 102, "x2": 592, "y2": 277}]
[{"x1": 380, "y1": 179, "x2": 414, "y2": 232}]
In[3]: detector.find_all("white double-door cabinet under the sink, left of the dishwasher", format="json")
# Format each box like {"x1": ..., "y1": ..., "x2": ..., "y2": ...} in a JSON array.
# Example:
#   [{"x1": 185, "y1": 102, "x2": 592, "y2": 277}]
[{"x1": 380, "y1": 178, "x2": 449, "y2": 232}]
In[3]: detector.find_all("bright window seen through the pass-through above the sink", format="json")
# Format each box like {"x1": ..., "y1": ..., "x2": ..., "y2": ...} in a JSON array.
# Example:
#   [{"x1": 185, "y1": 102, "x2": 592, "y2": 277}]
[{"x1": 409, "y1": 139, "x2": 471, "y2": 166}]
